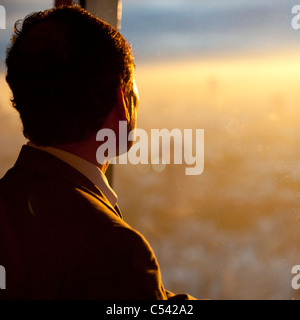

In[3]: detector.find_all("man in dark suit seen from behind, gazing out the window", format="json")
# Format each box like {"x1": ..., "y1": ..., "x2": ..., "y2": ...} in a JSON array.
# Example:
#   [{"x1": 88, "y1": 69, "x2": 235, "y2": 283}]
[{"x1": 0, "y1": 6, "x2": 193, "y2": 300}]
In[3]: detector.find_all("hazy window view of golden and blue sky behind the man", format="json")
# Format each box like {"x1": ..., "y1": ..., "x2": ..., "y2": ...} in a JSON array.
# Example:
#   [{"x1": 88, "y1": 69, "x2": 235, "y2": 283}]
[{"x1": 0, "y1": 0, "x2": 300, "y2": 299}]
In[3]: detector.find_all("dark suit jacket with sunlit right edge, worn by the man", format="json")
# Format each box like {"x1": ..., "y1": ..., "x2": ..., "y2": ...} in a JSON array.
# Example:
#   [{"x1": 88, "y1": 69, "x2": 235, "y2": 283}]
[{"x1": 0, "y1": 146, "x2": 193, "y2": 300}]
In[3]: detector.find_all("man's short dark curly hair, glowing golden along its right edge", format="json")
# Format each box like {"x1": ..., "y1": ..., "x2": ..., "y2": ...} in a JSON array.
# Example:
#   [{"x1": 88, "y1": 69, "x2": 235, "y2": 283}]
[{"x1": 6, "y1": 5, "x2": 134, "y2": 145}]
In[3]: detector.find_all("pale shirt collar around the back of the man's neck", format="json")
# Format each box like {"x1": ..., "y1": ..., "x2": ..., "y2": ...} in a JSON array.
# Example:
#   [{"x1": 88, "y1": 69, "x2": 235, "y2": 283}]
[{"x1": 27, "y1": 142, "x2": 118, "y2": 207}]
